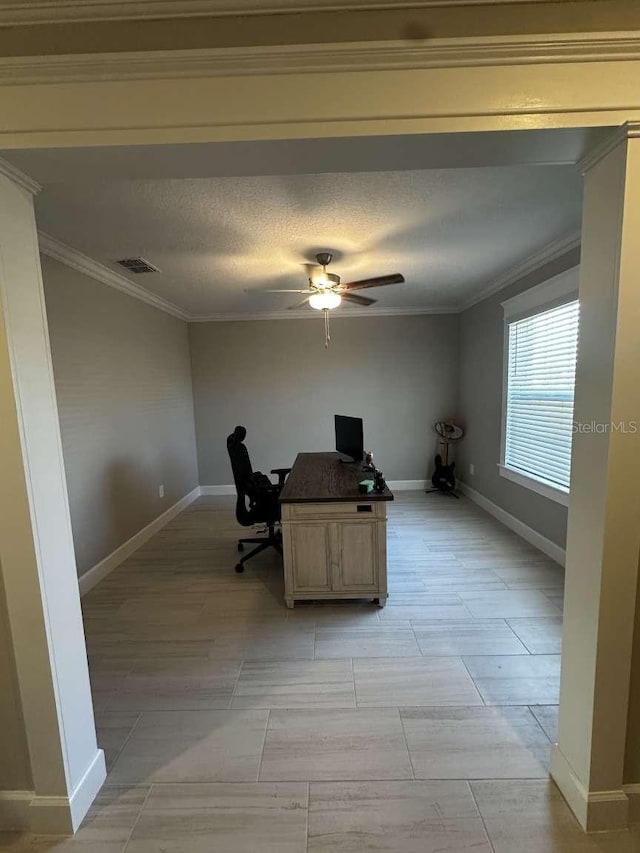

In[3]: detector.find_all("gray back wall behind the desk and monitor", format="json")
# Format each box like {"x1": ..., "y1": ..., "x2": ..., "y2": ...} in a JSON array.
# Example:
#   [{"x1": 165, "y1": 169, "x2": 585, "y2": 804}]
[{"x1": 189, "y1": 315, "x2": 458, "y2": 485}]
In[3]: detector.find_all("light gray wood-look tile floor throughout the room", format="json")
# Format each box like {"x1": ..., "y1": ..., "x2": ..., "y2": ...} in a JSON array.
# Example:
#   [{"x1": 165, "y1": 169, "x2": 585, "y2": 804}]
[{"x1": 0, "y1": 492, "x2": 640, "y2": 853}]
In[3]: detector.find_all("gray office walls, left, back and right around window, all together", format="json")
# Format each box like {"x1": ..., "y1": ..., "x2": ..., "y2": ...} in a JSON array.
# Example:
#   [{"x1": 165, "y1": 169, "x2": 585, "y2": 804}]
[{"x1": 43, "y1": 243, "x2": 578, "y2": 574}]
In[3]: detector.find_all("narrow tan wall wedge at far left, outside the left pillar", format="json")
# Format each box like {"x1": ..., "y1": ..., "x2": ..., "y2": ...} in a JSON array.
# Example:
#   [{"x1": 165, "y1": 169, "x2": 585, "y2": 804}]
[{"x1": 0, "y1": 566, "x2": 32, "y2": 791}]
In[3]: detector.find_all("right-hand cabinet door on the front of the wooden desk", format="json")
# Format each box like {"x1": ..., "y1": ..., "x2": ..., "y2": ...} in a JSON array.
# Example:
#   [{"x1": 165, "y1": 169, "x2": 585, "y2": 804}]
[{"x1": 333, "y1": 521, "x2": 378, "y2": 592}]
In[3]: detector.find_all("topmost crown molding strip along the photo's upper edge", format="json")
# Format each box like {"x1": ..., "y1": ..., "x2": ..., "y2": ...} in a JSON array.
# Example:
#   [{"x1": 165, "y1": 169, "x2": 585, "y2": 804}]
[{"x1": 0, "y1": 0, "x2": 576, "y2": 26}]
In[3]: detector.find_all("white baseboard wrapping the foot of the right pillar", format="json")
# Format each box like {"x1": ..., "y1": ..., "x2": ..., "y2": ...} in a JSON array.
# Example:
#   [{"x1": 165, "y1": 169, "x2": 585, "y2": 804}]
[{"x1": 551, "y1": 743, "x2": 629, "y2": 832}]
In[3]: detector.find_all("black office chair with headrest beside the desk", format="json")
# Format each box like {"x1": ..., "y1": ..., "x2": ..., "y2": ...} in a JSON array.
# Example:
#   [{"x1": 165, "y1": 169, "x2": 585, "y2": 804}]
[{"x1": 227, "y1": 426, "x2": 291, "y2": 572}]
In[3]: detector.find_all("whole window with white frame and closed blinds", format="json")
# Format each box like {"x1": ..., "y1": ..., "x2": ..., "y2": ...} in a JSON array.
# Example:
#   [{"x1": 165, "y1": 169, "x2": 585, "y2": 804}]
[{"x1": 500, "y1": 271, "x2": 579, "y2": 505}]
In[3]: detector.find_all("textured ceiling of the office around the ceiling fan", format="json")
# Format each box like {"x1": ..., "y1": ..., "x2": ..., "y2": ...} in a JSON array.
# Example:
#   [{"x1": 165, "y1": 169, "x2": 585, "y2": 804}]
[{"x1": 30, "y1": 166, "x2": 581, "y2": 314}]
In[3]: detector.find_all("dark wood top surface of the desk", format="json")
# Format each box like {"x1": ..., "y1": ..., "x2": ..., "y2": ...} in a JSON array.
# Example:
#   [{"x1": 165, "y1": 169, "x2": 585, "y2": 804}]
[{"x1": 280, "y1": 453, "x2": 393, "y2": 503}]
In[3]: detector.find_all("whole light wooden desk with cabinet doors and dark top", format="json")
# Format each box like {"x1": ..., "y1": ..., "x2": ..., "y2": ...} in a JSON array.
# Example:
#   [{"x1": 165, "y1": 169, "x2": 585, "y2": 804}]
[{"x1": 280, "y1": 453, "x2": 393, "y2": 607}]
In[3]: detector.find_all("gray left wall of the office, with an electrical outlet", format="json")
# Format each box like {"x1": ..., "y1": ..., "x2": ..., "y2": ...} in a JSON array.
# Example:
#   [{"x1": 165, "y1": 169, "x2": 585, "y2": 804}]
[{"x1": 42, "y1": 257, "x2": 198, "y2": 574}]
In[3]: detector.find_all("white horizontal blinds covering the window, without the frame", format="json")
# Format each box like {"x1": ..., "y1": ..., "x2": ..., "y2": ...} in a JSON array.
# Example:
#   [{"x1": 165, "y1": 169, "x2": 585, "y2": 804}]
[{"x1": 504, "y1": 300, "x2": 578, "y2": 491}]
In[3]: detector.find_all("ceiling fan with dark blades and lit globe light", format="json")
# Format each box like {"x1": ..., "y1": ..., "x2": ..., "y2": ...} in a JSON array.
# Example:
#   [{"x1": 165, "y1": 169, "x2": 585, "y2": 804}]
[{"x1": 263, "y1": 252, "x2": 404, "y2": 348}]
